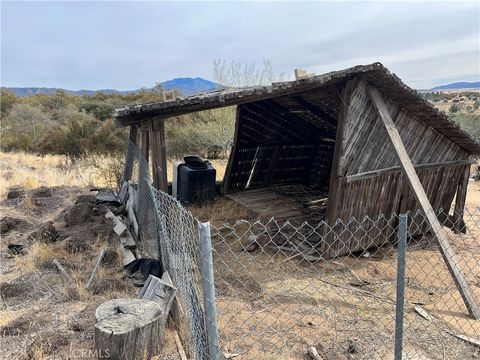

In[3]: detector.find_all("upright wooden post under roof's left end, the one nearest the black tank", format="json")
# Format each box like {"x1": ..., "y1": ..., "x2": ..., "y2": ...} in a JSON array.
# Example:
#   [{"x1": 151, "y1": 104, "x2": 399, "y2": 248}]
[{"x1": 150, "y1": 119, "x2": 168, "y2": 192}]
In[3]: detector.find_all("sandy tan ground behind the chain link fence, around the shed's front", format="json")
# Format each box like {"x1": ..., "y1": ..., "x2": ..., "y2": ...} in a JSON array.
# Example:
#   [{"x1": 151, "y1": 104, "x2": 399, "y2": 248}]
[{"x1": 192, "y1": 182, "x2": 480, "y2": 359}]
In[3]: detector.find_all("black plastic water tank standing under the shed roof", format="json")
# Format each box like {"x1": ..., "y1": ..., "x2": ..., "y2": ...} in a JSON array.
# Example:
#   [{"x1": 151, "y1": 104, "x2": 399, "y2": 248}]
[{"x1": 177, "y1": 156, "x2": 216, "y2": 204}]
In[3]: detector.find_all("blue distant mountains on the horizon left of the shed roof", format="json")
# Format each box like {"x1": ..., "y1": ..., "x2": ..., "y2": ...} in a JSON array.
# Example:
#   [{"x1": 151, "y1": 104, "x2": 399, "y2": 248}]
[{"x1": 5, "y1": 77, "x2": 220, "y2": 96}]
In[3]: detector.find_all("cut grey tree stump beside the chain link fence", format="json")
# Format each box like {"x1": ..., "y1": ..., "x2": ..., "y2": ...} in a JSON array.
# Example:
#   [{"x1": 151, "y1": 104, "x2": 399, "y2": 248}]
[{"x1": 95, "y1": 299, "x2": 165, "y2": 360}]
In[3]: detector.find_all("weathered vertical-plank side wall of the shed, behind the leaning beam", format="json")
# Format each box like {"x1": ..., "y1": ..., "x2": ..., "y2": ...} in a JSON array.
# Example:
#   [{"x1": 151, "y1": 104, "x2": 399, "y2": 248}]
[{"x1": 328, "y1": 81, "x2": 469, "y2": 256}]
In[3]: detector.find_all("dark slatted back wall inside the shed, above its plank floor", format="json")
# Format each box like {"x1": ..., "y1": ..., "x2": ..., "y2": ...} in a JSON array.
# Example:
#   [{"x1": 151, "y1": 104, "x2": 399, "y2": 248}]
[{"x1": 225, "y1": 89, "x2": 339, "y2": 193}]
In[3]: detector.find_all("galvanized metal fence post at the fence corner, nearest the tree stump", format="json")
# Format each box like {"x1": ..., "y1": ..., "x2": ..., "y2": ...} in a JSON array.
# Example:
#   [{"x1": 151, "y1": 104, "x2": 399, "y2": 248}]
[{"x1": 199, "y1": 222, "x2": 219, "y2": 360}]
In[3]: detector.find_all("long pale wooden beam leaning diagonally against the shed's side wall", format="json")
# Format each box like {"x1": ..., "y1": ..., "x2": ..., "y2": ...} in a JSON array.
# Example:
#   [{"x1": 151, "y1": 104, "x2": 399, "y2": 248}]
[{"x1": 367, "y1": 86, "x2": 480, "y2": 320}]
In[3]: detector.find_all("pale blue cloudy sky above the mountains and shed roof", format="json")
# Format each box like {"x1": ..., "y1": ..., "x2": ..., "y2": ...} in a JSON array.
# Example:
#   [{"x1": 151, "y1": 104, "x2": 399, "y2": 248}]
[{"x1": 1, "y1": 1, "x2": 480, "y2": 90}]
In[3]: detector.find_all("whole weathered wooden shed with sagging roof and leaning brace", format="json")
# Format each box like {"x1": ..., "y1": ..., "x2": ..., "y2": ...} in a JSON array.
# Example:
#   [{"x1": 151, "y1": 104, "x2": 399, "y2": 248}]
[{"x1": 116, "y1": 63, "x2": 480, "y2": 319}]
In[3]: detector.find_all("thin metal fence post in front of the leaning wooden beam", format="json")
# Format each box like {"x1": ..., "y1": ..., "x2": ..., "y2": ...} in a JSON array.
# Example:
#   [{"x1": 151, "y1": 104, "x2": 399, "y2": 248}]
[{"x1": 395, "y1": 214, "x2": 408, "y2": 360}]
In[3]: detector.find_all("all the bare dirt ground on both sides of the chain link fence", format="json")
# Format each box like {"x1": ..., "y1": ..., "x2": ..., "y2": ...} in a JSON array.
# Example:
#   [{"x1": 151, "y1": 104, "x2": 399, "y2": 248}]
[{"x1": 0, "y1": 176, "x2": 480, "y2": 360}]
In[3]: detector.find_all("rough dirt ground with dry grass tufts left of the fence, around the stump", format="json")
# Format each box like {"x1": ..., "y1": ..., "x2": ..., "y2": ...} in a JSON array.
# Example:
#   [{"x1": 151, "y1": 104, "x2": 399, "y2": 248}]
[{"x1": 0, "y1": 186, "x2": 179, "y2": 360}]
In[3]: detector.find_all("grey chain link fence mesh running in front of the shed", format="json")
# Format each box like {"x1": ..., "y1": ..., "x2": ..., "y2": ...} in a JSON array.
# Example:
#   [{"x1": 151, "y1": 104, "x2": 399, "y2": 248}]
[{"x1": 125, "y1": 141, "x2": 480, "y2": 359}]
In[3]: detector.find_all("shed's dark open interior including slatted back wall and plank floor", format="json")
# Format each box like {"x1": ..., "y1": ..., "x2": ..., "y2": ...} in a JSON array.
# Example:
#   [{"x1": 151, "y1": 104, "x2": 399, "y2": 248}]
[{"x1": 224, "y1": 88, "x2": 340, "y2": 224}]
